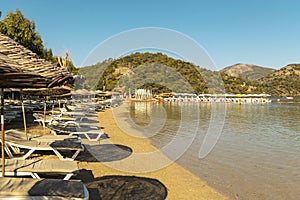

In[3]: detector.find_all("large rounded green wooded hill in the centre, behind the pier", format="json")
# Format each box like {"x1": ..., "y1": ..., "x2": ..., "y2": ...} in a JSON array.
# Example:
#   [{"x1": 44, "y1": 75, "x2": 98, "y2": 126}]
[{"x1": 79, "y1": 53, "x2": 222, "y2": 93}]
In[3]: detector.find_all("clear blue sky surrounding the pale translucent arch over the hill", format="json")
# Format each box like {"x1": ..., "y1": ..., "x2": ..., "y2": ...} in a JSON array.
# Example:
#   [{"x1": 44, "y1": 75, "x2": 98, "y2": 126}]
[{"x1": 0, "y1": 0, "x2": 300, "y2": 69}]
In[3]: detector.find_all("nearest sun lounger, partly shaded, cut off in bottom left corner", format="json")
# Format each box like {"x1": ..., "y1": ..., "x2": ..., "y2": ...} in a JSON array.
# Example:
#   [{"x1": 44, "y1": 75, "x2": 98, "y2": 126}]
[{"x1": 0, "y1": 177, "x2": 89, "y2": 200}]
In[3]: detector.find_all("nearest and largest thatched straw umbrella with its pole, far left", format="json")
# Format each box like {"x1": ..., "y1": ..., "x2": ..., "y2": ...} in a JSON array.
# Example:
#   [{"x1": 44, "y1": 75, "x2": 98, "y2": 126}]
[{"x1": 0, "y1": 33, "x2": 73, "y2": 176}]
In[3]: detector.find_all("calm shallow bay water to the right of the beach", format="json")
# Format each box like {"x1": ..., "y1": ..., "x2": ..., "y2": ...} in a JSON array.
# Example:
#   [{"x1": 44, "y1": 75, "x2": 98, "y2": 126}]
[{"x1": 130, "y1": 102, "x2": 300, "y2": 199}]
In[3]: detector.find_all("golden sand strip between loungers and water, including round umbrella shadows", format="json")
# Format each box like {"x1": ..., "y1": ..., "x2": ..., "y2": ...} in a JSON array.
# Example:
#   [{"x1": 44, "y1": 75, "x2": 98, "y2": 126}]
[{"x1": 7, "y1": 109, "x2": 228, "y2": 200}]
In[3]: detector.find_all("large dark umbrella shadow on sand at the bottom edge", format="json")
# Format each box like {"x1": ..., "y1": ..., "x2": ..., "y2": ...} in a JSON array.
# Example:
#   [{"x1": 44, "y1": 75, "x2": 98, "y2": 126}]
[{"x1": 76, "y1": 170, "x2": 168, "y2": 200}]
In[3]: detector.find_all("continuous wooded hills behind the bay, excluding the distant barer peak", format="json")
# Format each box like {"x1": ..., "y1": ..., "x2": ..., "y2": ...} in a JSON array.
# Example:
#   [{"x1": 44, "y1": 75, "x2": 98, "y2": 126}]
[{"x1": 77, "y1": 53, "x2": 300, "y2": 96}]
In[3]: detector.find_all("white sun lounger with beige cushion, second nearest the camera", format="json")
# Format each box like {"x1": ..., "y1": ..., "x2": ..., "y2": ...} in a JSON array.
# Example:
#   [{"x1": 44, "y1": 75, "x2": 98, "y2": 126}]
[{"x1": 0, "y1": 159, "x2": 79, "y2": 180}]
